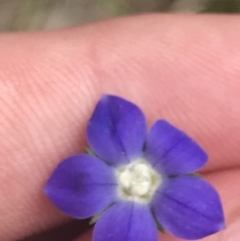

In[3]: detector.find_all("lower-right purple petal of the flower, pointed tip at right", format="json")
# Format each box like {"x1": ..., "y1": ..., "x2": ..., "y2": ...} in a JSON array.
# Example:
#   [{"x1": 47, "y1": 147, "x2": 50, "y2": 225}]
[{"x1": 151, "y1": 176, "x2": 224, "y2": 239}]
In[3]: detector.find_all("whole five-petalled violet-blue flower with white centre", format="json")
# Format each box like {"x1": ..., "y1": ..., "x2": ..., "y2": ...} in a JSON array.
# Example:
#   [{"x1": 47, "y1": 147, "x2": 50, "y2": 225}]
[{"x1": 44, "y1": 95, "x2": 224, "y2": 241}]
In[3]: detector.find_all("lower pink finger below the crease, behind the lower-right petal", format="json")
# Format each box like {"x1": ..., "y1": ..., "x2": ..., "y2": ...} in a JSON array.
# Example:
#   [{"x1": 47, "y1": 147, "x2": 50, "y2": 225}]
[{"x1": 75, "y1": 170, "x2": 240, "y2": 241}]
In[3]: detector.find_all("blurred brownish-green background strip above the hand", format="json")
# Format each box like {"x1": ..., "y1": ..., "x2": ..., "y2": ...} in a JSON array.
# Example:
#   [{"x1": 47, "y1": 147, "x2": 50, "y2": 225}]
[{"x1": 0, "y1": 0, "x2": 240, "y2": 32}]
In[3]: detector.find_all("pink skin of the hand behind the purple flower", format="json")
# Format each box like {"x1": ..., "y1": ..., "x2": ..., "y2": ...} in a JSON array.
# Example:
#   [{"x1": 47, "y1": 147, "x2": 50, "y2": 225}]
[{"x1": 0, "y1": 15, "x2": 240, "y2": 241}]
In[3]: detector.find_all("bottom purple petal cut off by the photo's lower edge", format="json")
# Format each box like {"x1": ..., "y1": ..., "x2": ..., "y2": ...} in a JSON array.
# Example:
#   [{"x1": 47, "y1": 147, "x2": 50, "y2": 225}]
[{"x1": 93, "y1": 202, "x2": 158, "y2": 241}]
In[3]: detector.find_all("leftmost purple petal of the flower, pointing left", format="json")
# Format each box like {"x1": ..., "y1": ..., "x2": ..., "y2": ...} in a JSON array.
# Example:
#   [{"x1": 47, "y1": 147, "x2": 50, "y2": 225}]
[{"x1": 44, "y1": 155, "x2": 116, "y2": 218}]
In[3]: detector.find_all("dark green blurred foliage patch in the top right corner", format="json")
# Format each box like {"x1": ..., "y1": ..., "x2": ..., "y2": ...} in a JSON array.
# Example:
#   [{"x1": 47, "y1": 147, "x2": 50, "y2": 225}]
[{"x1": 202, "y1": 0, "x2": 240, "y2": 13}]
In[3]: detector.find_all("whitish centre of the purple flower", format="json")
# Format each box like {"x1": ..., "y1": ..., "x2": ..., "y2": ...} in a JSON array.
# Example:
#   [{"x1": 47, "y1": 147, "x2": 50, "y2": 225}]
[{"x1": 117, "y1": 160, "x2": 161, "y2": 202}]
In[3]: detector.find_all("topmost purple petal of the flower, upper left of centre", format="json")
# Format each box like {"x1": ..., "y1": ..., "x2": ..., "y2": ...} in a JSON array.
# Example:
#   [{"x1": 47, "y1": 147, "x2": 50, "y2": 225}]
[{"x1": 87, "y1": 95, "x2": 146, "y2": 166}]
